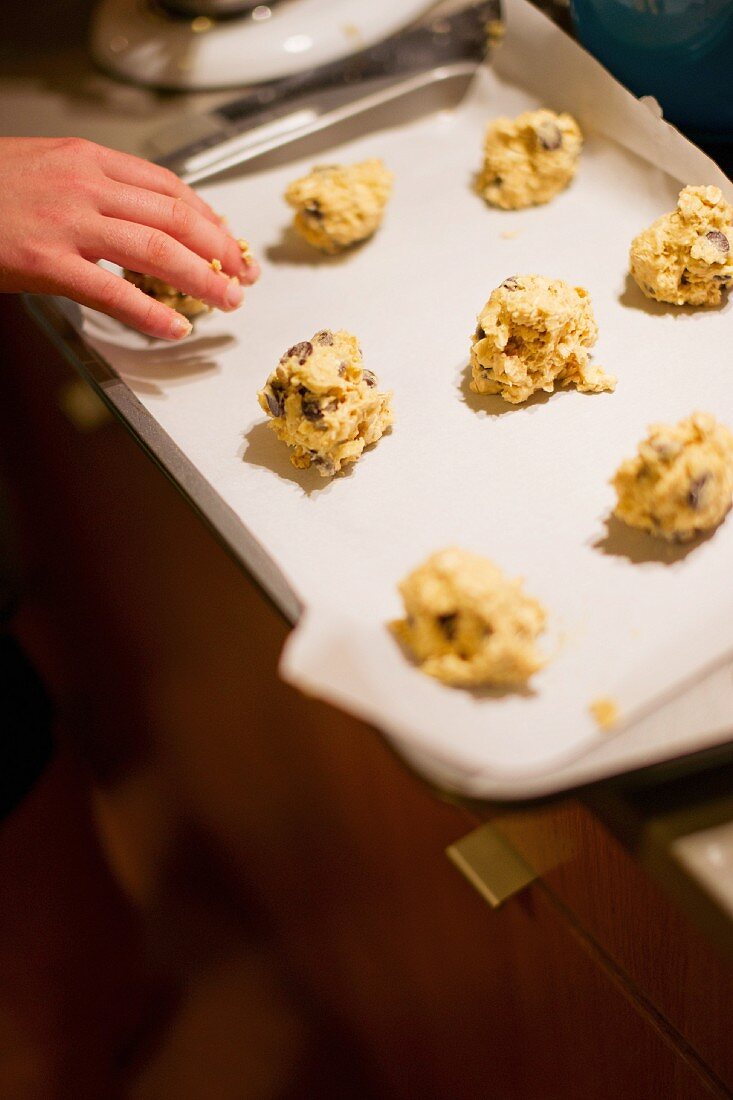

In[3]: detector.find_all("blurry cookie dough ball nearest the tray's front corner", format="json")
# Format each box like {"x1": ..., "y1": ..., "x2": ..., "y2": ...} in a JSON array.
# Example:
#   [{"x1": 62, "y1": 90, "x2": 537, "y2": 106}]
[{"x1": 392, "y1": 548, "x2": 547, "y2": 688}]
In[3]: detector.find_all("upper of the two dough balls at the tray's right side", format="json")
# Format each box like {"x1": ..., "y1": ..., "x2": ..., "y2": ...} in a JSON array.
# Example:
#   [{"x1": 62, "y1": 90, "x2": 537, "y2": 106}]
[{"x1": 630, "y1": 187, "x2": 733, "y2": 306}]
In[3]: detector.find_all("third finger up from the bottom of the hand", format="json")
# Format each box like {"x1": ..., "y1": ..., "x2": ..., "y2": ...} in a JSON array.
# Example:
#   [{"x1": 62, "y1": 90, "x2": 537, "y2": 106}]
[{"x1": 99, "y1": 182, "x2": 258, "y2": 285}]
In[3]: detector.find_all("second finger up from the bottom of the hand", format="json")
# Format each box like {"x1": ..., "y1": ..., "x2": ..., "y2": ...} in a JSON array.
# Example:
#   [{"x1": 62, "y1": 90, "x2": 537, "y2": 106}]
[{"x1": 84, "y1": 218, "x2": 243, "y2": 310}]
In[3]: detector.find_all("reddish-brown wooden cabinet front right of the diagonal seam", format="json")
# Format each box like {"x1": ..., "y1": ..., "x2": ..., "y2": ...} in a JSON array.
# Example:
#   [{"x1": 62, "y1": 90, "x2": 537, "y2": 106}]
[{"x1": 490, "y1": 801, "x2": 733, "y2": 1090}]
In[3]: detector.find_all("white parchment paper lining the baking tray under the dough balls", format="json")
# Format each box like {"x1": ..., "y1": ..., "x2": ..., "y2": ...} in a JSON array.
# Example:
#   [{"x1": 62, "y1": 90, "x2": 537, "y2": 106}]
[{"x1": 68, "y1": 0, "x2": 733, "y2": 794}]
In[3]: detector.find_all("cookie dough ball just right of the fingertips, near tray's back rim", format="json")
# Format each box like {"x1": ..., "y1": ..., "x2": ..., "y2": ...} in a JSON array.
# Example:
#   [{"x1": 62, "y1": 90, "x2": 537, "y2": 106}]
[{"x1": 285, "y1": 160, "x2": 394, "y2": 254}]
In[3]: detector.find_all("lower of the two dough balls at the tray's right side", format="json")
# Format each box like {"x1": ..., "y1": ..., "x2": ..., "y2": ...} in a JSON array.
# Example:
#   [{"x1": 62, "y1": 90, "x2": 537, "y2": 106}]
[{"x1": 612, "y1": 413, "x2": 733, "y2": 542}]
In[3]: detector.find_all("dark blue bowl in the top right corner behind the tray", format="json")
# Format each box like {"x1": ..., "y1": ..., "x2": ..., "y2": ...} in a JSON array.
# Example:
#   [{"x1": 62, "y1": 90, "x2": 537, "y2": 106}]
[{"x1": 570, "y1": 0, "x2": 733, "y2": 143}]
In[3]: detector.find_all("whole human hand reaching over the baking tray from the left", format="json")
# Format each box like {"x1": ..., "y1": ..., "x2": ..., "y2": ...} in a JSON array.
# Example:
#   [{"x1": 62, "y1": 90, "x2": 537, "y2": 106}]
[{"x1": 0, "y1": 138, "x2": 260, "y2": 340}]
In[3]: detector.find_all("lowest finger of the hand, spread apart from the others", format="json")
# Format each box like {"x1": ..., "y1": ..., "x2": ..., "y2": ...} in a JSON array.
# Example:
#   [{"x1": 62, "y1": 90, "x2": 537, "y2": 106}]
[{"x1": 54, "y1": 256, "x2": 192, "y2": 340}]
